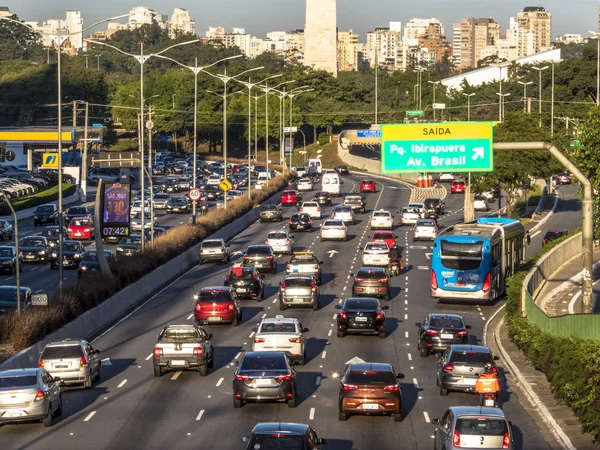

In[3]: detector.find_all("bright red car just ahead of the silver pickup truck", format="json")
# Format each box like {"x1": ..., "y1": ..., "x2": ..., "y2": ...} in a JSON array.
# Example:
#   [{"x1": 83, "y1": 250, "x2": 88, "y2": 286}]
[{"x1": 194, "y1": 286, "x2": 242, "y2": 327}]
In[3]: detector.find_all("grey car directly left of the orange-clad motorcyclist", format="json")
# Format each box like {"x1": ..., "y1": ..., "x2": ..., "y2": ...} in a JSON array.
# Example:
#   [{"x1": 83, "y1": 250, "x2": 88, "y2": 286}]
[{"x1": 436, "y1": 345, "x2": 499, "y2": 396}]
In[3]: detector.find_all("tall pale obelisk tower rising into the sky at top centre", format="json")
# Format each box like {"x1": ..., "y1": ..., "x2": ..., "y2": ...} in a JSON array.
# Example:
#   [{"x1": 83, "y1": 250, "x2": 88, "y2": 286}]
[{"x1": 304, "y1": 0, "x2": 337, "y2": 75}]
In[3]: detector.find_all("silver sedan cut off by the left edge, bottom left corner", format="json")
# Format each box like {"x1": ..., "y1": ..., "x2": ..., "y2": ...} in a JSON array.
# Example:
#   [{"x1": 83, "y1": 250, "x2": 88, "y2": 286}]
[{"x1": 0, "y1": 368, "x2": 62, "y2": 427}]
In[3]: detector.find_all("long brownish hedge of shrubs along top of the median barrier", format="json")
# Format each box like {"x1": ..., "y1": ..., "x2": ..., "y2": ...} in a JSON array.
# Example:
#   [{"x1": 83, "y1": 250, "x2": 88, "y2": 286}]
[{"x1": 0, "y1": 175, "x2": 291, "y2": 357}]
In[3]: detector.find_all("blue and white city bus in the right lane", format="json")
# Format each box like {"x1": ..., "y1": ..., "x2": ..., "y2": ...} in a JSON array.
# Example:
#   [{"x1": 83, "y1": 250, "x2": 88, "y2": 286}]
[{"x1": 430, "y1": 217, "x2": 525, "y2": 302}]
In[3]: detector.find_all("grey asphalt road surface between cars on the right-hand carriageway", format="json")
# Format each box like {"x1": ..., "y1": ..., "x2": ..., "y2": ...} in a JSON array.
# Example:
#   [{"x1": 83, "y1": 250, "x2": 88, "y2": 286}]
[{"x1": 0, "y1": 176, "x2": 548, "y2": 450}]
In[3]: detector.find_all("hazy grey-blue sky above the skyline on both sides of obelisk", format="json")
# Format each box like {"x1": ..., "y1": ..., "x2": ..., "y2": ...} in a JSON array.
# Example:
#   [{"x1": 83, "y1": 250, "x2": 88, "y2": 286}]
[{"x1": 5, "y1": 0, "x2": 600, "y2": 42}]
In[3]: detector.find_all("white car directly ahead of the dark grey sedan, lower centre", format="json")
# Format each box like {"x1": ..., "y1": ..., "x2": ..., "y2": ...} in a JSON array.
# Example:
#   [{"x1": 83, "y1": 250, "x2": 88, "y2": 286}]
[{"x1": 252, "y1": 316, "x2": 309, "y2": 364}]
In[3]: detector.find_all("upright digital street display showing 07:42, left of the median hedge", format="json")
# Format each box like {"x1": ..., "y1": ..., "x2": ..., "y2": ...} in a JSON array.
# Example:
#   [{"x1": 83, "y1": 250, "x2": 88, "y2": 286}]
[{"x1": 101, "y1": 183, "x2": 131, "y2": 241}]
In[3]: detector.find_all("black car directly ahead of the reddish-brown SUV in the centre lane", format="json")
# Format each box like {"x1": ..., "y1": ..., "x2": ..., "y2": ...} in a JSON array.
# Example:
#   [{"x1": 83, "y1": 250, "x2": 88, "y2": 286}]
[{"x1": 335, "y1": 297, "x2": 389, "y2": 339}]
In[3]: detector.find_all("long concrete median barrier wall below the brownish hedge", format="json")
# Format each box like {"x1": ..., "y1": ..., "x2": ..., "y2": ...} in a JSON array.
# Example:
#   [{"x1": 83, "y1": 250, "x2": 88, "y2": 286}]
[{"x1": 0, "y1": 187, "x2": 287, "y2": 370}]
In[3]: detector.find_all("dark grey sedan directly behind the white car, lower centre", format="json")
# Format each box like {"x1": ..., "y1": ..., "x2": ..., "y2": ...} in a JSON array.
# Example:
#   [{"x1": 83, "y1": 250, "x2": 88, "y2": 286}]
[{"x1": 233, "y1": 352, "x2": 296, "y2": 408}]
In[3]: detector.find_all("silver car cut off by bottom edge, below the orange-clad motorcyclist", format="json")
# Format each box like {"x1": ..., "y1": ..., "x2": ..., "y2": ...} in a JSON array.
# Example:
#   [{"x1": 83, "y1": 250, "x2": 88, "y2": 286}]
[{"x1": 431, "y1": 406, "x2": 514, "y2": 450}]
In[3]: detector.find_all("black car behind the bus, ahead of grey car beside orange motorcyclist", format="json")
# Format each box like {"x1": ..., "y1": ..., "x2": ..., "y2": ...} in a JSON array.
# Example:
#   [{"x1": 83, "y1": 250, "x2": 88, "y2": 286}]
[{"x1": 417, "y1": 314, "x2": 471, "y2": 358}]
